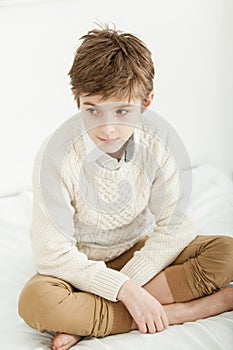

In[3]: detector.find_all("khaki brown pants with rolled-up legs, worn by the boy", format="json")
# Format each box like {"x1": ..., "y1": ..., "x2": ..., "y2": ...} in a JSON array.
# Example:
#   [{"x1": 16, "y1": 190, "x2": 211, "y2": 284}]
[{"x1": 19, "y1": 236, "x2": 233, "y2": 337}]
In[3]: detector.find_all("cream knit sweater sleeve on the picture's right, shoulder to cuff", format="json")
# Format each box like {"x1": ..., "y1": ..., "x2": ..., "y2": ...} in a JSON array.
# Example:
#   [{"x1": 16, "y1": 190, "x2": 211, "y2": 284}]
[{"x1": 120, "y1": 130, "x2": 196, "y2": 286}]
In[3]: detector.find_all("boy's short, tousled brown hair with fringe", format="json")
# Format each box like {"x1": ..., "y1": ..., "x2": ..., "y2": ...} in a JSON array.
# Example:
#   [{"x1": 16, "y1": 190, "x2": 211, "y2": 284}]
[{"x1": 68, "y1": 26, "x2": 154, "y2": 107}]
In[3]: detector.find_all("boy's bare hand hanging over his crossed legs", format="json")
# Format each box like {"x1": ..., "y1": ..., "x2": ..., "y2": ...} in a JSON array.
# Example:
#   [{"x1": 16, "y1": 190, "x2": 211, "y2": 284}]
[{"x1": 117, "y1": 280, "x2": 168, "y2": 333}]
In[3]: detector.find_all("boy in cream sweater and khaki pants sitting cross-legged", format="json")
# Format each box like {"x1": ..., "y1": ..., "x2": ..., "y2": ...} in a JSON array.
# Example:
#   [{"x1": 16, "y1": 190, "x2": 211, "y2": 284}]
[{"x1": 19, "y1": 28, "x2": 233, "y2": 350}]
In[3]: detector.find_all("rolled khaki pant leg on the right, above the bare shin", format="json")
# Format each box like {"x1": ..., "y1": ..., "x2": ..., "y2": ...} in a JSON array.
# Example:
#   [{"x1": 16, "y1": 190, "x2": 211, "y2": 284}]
[{"x1": 164, "y1": 236, "x2": 233, "y2": 302}]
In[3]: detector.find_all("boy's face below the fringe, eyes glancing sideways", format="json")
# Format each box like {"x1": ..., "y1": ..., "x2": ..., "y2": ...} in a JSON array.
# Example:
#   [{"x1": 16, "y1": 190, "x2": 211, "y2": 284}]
[{"x1": 80, "y1": 95, "x2": 143, "y2": 158}]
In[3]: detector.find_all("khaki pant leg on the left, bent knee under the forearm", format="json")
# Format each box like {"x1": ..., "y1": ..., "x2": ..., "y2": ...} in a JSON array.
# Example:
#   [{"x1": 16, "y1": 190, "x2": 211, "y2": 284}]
[{"x1": 18, "y1": 238, "x2": 149, "y2": 337}]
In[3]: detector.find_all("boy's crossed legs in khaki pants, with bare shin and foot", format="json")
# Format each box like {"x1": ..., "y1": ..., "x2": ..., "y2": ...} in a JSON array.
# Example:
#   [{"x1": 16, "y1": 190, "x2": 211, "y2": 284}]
[{"x1": 19, "y1": 236, "x2": 233, "y2": 350}]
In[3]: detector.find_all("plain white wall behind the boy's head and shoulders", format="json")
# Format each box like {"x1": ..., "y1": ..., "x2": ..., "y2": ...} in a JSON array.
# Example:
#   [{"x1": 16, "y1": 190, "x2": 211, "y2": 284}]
[{"x1": 0, "y1": 0, "x2": 233, "y2": 192}]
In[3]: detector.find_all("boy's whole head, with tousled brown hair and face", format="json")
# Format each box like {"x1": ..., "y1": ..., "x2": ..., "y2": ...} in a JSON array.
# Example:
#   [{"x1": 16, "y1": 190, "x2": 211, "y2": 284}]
[{"x1": 69, "y1": 27, "x2": 154, "y2": 158}]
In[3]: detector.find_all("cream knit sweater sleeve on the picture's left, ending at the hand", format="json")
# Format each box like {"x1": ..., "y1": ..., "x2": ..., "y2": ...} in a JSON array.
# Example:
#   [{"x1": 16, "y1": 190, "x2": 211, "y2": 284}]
[{"x1": 30, "y1": 139, "x2": 129, "y2": 301}]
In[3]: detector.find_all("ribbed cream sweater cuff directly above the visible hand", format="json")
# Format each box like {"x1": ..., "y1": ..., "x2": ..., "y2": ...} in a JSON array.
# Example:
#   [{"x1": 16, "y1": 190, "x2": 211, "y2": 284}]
[{"x1": 89, "y1": 268, "x2": 129, "y2": 301}]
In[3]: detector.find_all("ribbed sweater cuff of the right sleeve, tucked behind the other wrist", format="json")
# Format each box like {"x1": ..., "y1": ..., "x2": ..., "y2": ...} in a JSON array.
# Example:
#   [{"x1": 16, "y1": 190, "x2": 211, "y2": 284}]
[{"x1": 120, "y1": 256, "x2": 156, "y2": 286}]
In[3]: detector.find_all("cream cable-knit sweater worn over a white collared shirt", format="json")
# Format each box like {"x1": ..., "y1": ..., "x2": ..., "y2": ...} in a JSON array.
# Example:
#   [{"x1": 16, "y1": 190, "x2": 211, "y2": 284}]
[{"x1": 30, "y1": 111, "x2": 196, "y2": 301}]
